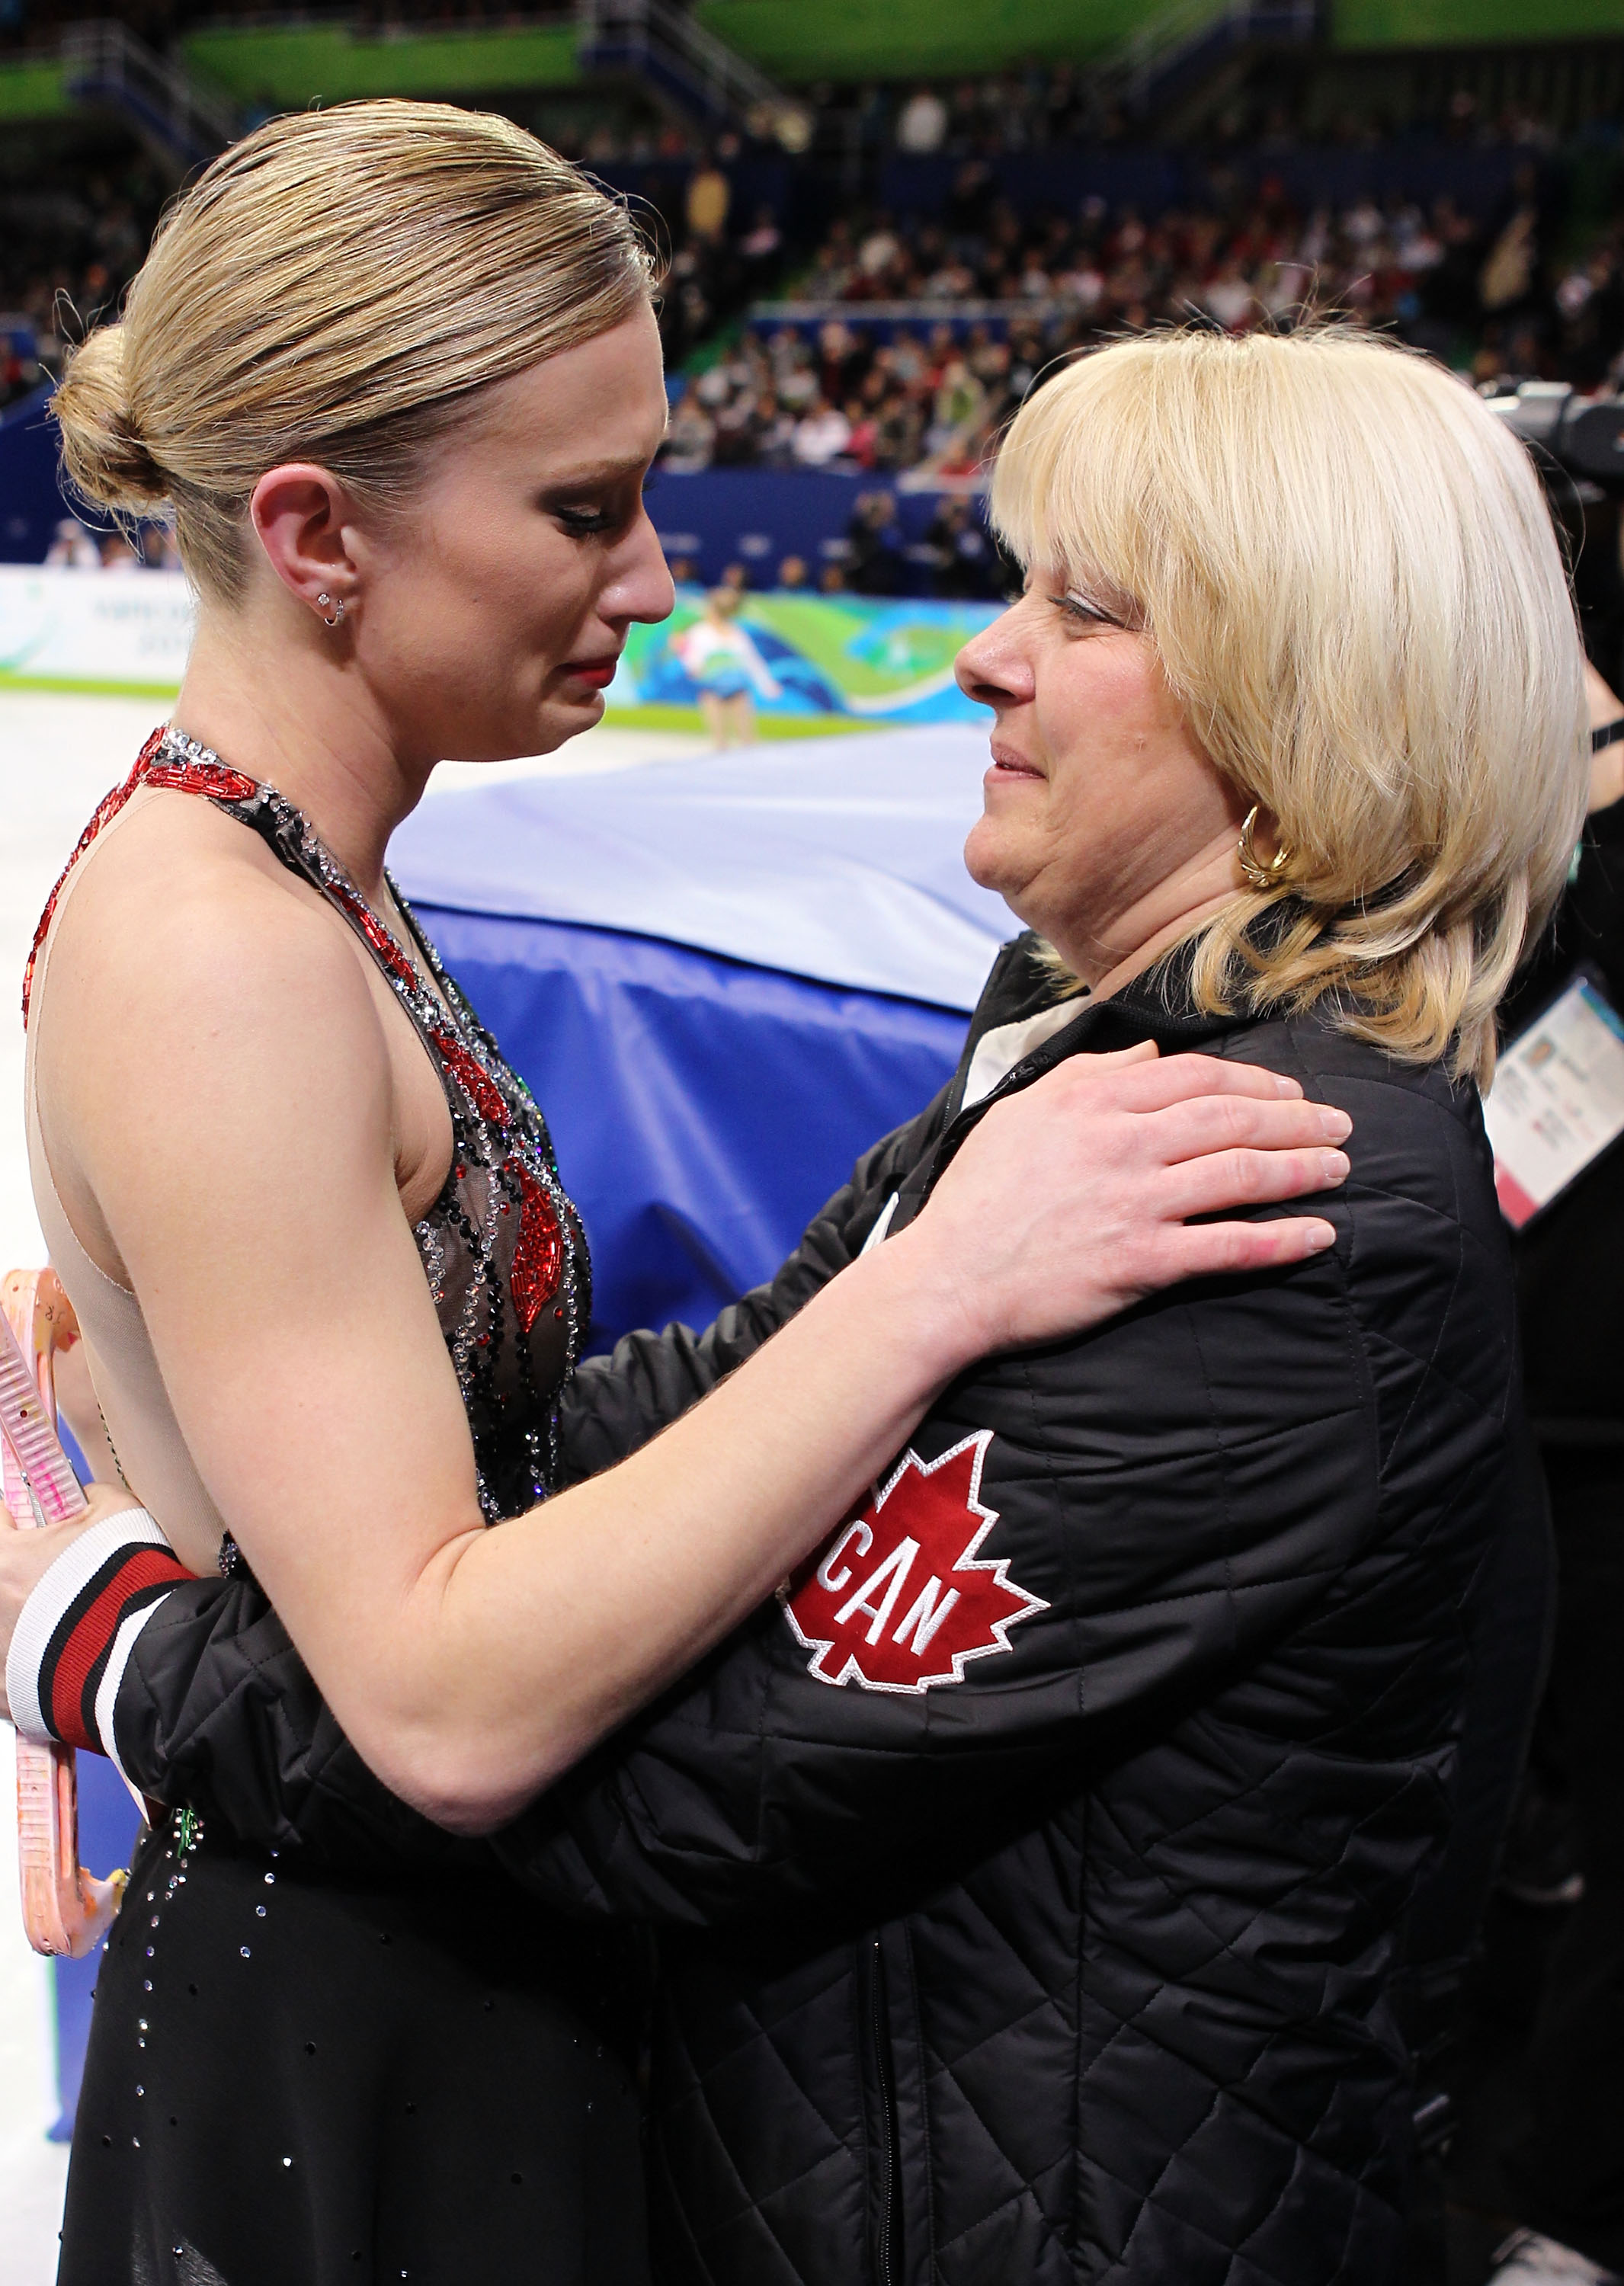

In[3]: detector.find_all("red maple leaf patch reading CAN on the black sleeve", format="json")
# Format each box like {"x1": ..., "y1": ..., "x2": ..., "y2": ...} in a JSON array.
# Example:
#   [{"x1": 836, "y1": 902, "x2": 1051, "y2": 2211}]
[{"x1": 784, "y1": 1429, "x2": 1048, "y2": 1692}]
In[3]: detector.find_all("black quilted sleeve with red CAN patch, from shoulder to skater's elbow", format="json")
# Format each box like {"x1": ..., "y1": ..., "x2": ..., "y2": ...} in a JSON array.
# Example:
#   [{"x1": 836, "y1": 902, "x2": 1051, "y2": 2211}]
[{"x1": 496, "y1": 1058, "x2": 1512, "y2": 1925}]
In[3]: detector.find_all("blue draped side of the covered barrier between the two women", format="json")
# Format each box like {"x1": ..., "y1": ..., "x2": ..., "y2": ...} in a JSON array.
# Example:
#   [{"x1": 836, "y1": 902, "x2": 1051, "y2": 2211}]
[{"x1": 53, "y1": 903, "x2": 966, "y2": 2140}]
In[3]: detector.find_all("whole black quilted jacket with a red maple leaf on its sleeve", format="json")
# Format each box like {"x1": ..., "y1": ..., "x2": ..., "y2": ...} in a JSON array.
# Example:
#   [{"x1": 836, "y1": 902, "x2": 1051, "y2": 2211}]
[{"x1": 117, "y1": 940, "x2": 1544, "y2": 2286}]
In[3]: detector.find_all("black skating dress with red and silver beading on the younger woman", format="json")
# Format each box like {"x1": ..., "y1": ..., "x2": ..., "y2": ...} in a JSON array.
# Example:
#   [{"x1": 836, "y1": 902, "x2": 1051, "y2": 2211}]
[{"x1": 30, "y1": 732, "x2": 645, "y2": 2286}]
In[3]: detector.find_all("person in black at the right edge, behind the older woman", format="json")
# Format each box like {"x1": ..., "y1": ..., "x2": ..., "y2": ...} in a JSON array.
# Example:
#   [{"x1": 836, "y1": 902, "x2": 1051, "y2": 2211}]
[{"x1": 1480, "y1": 645, "x2": 1624, "y2": 2286}]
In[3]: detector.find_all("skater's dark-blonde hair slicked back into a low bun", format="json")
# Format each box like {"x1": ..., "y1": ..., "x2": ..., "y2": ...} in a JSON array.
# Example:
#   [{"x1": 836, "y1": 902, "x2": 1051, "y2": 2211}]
[{"x1": 53, "y1": 103, "x2": 654, "y2": 601}]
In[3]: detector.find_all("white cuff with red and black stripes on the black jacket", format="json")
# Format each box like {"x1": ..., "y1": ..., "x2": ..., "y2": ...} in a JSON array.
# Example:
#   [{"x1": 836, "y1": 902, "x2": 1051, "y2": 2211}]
[{"x1": 5, "y1": 1509, "x2": 192, "y2": 1763}]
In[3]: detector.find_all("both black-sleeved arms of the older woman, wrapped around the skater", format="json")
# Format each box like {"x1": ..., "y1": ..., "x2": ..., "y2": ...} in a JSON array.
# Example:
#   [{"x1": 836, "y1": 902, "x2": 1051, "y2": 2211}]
[{"x1": 89, "y1": 1038, "x2": 1408, "y2": 1923}]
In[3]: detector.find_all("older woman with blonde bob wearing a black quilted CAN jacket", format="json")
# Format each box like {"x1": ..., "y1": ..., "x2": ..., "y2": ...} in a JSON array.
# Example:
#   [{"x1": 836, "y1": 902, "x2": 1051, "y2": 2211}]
[{"x1": 6, "y1": 331, "x2": 1587, "y2": 2286}]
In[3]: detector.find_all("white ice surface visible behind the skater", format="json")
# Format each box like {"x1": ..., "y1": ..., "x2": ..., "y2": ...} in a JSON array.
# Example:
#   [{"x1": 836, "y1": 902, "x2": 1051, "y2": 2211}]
[{"x1": 0, "y1": 693, "x2": 706, "y2": 2286}]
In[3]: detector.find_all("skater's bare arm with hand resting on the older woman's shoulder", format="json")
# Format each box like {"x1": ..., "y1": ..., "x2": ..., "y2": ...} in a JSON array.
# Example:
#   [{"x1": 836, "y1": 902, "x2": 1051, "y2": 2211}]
[{"x1": 25, "y1": 896, "x2": 1343, "y2": 1827}]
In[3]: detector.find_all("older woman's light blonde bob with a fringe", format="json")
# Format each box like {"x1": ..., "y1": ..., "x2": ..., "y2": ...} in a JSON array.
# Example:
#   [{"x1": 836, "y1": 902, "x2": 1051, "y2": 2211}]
[{"x1": 993, "y1": 325, "x2": 1590, "y2": 1086}]
